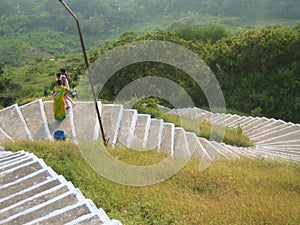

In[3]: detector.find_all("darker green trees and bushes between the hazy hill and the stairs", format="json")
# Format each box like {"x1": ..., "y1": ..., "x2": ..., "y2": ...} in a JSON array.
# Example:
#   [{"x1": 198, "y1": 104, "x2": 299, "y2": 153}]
[{"x1": 0, "y1": 26, "x2": 300, "y2": 123}]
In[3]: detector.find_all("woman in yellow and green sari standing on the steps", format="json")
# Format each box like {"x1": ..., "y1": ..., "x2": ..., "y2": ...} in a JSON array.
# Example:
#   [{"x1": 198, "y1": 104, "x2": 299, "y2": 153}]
[{"x1": 52, "y1": 80, "x2": 68, "y2": 120}]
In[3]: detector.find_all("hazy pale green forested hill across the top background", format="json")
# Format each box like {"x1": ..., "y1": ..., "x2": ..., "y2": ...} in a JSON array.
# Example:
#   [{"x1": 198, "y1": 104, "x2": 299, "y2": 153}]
[{"x1": 0, "y1": 0, "x2": 300, "y2": 66}]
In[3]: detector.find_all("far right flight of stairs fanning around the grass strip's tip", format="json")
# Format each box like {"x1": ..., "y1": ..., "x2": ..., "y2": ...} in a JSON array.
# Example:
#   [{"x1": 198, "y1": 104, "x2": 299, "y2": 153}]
[{"x1": 168, "y1": 108, "x2": 300, "y2": 162}]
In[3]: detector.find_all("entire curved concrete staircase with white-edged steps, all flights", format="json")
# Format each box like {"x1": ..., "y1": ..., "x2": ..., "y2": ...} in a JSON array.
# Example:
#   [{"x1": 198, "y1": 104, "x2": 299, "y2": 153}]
[{"x1": 0, "y1": 99, "x2": 300, "y2": 225}]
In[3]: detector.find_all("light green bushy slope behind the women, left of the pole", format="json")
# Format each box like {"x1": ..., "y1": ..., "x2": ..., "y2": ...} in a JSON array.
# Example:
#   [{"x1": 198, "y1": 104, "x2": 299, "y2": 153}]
[{"x1": 0, "y1": 54, "x2": 84, "y2": 108}]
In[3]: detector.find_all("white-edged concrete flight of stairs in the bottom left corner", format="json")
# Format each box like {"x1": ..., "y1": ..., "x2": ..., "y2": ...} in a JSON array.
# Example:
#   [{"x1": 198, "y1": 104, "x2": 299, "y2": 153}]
[{"x1": 0, "y1": 150, "x2": 121, "y2": 225}]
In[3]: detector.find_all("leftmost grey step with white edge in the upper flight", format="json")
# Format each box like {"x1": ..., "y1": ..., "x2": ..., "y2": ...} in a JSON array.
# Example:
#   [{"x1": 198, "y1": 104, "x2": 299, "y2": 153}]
[{"x1": 0, "y1": 105, "x2": 33, "y2": 140}]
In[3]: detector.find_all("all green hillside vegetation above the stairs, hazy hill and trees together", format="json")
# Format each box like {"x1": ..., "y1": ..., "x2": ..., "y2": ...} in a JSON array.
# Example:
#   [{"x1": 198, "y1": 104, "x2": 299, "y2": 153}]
[{"x1": 0, "y1": 0, "x2": 300, "y2": 123}]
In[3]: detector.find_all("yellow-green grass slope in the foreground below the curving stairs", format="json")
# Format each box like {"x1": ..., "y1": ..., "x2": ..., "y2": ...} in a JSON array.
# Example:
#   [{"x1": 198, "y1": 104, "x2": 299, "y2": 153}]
[{"x1": 3, "y1": 141, "x2": 300, "y2": 225}]
